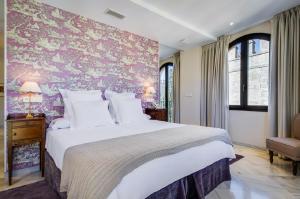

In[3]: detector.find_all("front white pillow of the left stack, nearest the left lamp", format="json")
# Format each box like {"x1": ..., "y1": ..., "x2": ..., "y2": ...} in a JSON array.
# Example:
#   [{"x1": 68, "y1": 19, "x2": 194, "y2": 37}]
[{"x1": 71, "y1": 100, "x2": 114, "y2": 128}]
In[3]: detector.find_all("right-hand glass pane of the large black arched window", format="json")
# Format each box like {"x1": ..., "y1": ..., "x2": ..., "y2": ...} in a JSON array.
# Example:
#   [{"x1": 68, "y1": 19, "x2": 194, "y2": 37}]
[{"x1": 248, "y1": 39, "x2": 270, "y2": 106}]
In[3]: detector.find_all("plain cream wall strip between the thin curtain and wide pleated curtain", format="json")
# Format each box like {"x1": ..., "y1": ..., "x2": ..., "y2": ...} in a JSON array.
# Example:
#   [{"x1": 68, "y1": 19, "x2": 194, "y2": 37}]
[{"x1": 180, "y1": 47, "x2": 202, "y2": 124}]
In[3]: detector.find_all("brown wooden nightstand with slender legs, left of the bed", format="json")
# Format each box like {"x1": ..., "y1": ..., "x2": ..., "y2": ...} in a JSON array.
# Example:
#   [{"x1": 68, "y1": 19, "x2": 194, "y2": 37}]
[{"x1": 7, "y1": 114, "x2": 45, "y2": 185}]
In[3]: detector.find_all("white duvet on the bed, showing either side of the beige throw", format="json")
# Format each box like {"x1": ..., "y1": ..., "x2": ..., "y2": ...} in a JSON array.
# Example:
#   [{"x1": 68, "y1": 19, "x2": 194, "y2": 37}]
[{"x1": 46, "y1": 120, "x2": 235, "y2": 199}]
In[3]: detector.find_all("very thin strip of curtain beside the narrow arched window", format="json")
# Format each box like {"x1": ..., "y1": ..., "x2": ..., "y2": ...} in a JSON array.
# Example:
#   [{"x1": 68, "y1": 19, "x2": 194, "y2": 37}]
[{"x1": 173, "y1": 52, "x2": 180, "y2": 123}]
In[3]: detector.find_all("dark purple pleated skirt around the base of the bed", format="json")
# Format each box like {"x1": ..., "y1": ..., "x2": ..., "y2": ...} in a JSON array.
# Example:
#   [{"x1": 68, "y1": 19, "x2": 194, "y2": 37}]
[{"x1": 45, "y1": 152, "x2": 231, "y2": 199}]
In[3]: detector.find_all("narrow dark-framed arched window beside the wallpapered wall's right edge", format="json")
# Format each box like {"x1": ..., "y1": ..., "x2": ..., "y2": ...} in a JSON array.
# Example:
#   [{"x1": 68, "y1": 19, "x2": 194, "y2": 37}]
[{"x1": 159, "y1": 63, "x2": 174, "y2": 122}]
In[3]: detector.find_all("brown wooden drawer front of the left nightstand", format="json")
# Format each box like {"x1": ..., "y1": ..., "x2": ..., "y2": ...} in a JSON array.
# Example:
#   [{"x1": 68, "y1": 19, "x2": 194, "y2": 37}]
[{"x1": 12, "y1": 126, "x2": 42, "y2": 140}]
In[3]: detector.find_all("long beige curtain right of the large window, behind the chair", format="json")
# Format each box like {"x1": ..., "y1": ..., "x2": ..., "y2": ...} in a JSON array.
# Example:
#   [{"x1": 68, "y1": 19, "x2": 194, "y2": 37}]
[{"x1": 269, "y1": 6, "x2": 300, "y2": 137}]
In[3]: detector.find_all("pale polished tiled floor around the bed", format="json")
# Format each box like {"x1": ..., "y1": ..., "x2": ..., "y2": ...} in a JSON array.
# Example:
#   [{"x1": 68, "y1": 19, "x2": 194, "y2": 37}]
[{"x1": 0, "y1": 146, "x2": 300, "y2": 199}]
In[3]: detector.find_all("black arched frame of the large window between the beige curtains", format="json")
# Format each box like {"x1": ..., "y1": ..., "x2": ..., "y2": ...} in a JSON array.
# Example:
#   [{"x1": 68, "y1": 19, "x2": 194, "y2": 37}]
[{"x1": 228, "y1": 33, "x2": 271, "y2": 112}]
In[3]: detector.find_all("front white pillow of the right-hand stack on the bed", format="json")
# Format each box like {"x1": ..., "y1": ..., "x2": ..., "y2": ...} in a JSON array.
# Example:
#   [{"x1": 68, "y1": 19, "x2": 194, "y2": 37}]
[{"x1": 112, "y1": 97, "x2": 146, "y2": 124}]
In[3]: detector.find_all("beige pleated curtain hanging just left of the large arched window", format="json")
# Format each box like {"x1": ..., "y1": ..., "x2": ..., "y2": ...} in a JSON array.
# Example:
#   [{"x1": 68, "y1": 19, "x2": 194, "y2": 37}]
[{"x1": 200, "y1": 36, "x2": 229, "y2": 129}]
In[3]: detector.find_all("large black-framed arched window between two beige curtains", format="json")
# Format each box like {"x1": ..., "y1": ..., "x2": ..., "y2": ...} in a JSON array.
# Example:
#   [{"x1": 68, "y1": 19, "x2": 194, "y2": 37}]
[{"x1": 228, "y1": 34, "x2": 270, "y2": 111}]
